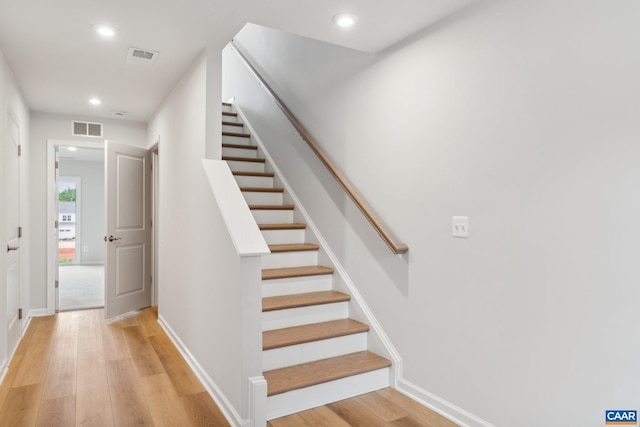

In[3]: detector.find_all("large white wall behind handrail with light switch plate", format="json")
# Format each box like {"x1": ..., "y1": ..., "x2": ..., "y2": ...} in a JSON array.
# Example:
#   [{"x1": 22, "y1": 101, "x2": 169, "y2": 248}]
[{"x1": 228, "y1": 0, "x2": 640, "y2": 426}]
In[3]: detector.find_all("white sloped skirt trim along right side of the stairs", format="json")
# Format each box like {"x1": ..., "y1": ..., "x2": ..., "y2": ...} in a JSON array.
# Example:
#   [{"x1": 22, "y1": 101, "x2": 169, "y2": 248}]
[{"x1": 233, "y1": 104, "x2": 402, "y2": 378}]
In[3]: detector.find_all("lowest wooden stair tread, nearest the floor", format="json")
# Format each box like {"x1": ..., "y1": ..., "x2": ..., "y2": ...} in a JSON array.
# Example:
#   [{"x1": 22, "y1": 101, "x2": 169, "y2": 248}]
[{"x1": 264, "y1": 351, "x2": 391, "y2": 396}]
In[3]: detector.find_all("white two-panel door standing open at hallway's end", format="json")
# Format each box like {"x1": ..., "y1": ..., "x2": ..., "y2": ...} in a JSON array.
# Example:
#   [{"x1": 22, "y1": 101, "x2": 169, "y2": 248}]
[{"x1": 105, "y1": 142, "x2": 152, "y2": 318}]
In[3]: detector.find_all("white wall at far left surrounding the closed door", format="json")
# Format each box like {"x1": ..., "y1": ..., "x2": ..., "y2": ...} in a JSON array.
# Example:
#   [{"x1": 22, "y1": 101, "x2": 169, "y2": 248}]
[{"x1": 0, "y1": 51, "x2": 32, "y2": 376}]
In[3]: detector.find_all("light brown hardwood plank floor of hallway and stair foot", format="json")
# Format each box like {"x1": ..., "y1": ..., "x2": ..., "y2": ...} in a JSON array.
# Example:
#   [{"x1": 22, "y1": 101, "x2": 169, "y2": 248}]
[{"x1": 0, "y1": 308, "x2": 455, "y2": 427}]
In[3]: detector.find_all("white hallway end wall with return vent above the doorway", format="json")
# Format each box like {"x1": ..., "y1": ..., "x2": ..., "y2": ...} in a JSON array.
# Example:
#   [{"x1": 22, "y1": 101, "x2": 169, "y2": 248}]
[{"x1": 29, "y1": 112, "x2": 147, "y2": 309}]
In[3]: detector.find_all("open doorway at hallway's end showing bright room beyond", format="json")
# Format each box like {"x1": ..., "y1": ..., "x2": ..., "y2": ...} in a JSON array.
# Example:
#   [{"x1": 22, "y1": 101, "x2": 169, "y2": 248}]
[{"x1": 56, "y1": 145, "x2": 105, "y2": 311}]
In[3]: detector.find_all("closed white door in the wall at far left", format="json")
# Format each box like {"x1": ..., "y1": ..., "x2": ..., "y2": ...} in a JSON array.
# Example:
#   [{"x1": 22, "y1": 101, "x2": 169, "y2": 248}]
[{"x1": 3, "y1": 115, "x2": 22, "y2": 354}]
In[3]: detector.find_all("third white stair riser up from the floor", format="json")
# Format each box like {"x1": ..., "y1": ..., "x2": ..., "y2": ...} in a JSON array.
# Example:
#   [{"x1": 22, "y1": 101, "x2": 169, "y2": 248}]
[{"x1": 262, "y1": 301, "x2": 349, "y2": 331}]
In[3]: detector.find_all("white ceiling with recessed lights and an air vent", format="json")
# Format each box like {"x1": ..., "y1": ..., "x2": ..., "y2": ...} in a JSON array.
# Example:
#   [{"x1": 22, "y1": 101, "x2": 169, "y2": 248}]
[{"x1": 0, "y1": 0, "x2": 473, "y2": 121}]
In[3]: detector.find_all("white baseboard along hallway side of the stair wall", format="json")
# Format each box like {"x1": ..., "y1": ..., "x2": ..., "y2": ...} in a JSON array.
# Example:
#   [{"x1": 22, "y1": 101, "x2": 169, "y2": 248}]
[{"x1": 158, "y1": 315, "x2": 245, "y2": 427}]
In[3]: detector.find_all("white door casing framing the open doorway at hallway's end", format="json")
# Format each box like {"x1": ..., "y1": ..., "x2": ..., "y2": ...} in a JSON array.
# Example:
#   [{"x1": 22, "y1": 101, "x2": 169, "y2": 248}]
[{"x1": 46, "y1": 139, "x2": 104, "y2": 314}]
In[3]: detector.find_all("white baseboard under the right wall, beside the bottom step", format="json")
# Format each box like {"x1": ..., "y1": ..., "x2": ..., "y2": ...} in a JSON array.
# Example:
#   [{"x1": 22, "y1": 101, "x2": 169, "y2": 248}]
[{"x1": 397, "y1": 378, "x2": 495, "y2": 427}]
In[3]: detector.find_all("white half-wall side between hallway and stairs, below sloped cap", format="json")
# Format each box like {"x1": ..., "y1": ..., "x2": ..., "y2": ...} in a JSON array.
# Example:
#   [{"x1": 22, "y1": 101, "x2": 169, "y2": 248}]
[{"x1": 148, "y1": 50, "x2": 255, "y2": 424}]
